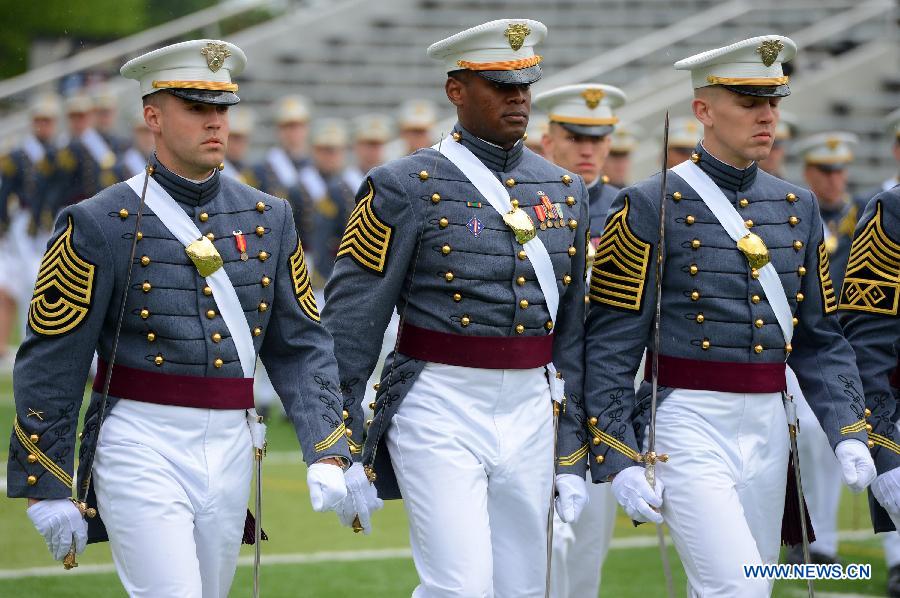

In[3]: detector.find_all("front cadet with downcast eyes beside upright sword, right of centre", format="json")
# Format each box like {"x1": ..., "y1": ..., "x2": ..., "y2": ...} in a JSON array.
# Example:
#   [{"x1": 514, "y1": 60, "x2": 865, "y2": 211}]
[{"x1": 585, "y1": 35, "x2": 875, "y2": 597}]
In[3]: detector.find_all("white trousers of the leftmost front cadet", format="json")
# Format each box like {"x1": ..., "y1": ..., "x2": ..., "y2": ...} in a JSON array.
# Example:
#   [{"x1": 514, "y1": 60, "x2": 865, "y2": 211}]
[{"x1": 94, "y1": 400, "x2": 253, "y2": 598}]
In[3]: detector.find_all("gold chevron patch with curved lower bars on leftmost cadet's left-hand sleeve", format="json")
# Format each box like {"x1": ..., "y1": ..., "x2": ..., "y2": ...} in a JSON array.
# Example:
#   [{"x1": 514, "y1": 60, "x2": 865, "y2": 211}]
[{"x1": 28, "y1": 216, "x2": 96, "y2": 336}]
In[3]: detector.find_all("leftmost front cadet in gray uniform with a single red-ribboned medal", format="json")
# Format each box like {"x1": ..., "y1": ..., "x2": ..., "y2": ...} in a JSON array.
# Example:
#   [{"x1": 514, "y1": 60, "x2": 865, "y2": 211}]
[{"x1": 7, "y1": 40, "x2": 358, "y2": 598}]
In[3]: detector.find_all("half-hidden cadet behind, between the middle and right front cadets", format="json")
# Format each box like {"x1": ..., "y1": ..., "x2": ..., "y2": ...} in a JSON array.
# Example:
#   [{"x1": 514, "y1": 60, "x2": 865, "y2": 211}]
[{"x1": 534, "y1": 83, "x2": 625, "y2": 598}]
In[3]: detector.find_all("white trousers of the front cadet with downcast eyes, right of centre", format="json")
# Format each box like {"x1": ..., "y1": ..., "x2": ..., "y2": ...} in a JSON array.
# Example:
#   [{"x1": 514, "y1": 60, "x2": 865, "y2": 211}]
[{"x1": 656, "y1": 389, "x2": 790, "y2": 598}]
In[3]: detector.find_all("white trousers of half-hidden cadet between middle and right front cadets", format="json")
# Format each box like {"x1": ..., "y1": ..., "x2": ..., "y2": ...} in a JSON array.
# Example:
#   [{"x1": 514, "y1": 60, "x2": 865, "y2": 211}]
[{"x1": 550, "y1": 473, "x2": 616, "y2": 598}]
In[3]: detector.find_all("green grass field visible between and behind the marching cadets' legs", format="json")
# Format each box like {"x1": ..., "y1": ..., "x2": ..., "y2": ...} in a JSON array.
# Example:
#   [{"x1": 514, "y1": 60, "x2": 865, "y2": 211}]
[{"x1": 0, "y1": 375, "x2": 886, "y2": 598}]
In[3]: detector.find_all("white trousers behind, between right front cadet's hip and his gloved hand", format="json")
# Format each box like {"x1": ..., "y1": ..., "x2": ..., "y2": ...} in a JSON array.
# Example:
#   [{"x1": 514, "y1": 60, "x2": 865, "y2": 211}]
[{"x1": 787, "y1": 368, "x2": 842, "y2": 557}]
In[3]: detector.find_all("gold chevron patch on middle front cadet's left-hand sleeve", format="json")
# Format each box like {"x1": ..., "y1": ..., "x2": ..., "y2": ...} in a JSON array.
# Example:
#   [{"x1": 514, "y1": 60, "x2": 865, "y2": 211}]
[{"x1": 335, "y1": 178, "x2": 393, "y2": 275}]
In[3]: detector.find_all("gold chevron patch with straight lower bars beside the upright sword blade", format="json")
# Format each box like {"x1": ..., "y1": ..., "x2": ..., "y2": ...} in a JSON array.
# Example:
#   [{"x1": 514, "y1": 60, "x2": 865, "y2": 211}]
[{"x1": 589, "y1": 196, "x2": 651, "y2": 311}]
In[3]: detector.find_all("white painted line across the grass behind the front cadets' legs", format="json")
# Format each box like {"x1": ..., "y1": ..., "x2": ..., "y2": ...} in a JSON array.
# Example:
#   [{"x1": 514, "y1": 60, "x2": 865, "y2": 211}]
[{"x1": 0, "y1": 530, "x2": 873, "y2": 580}]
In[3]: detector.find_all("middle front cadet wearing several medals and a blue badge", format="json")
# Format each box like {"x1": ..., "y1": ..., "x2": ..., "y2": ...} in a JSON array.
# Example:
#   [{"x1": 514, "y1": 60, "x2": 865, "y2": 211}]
[{"x1": 323, "y1": 19, "x2": 588, "y2": 597}]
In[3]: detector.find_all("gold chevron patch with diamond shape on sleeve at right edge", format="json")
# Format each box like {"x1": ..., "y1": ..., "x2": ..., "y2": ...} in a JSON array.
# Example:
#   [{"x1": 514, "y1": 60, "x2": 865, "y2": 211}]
[{"x1": 840, "y1": 201, "x2": 900, "y2": 316}]
